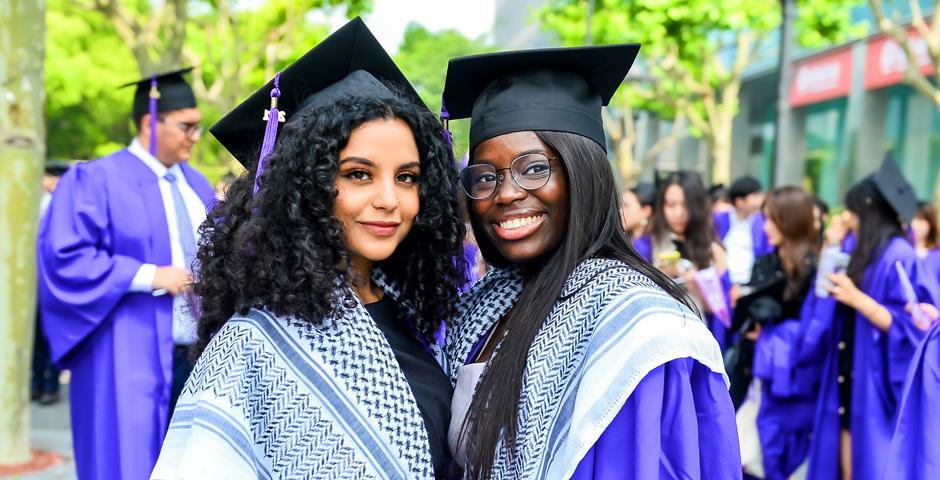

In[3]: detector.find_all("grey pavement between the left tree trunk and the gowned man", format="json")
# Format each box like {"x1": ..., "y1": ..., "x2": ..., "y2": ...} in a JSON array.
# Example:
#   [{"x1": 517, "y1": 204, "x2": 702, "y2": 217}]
[{"x1": 0, "y1": 384, "x2": 76, "y2": 480}]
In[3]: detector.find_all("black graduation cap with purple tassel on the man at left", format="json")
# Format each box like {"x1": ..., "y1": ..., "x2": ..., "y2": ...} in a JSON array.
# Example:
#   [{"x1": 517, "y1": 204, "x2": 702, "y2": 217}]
[{"x1": 121, "y1": 67, "x2": 196, "y2": 155}]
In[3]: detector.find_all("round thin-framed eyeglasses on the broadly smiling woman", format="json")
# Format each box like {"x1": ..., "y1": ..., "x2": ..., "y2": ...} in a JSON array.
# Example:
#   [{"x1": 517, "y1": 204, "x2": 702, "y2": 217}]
[{"x1": 460, "y1": 153, "x2": 558, "y2": 200}]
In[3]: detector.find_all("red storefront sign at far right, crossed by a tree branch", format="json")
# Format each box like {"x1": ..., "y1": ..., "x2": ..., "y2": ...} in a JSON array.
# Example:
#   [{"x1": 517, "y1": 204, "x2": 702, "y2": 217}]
[{"x1": 865, "y1": 28, "x2": 932, "y2": 90}]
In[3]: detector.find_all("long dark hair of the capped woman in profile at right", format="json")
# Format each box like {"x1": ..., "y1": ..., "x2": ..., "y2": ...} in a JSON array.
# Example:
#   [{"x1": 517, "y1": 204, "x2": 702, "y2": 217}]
[{"x1": 845, "y1": 177, "x2": 904, "y2": 288}]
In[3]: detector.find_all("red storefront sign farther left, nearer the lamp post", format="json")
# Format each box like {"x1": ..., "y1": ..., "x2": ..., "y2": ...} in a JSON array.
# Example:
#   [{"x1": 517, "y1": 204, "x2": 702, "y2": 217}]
[{"x1": 790, "y1": 48, "x2": 852, "y2": 107}]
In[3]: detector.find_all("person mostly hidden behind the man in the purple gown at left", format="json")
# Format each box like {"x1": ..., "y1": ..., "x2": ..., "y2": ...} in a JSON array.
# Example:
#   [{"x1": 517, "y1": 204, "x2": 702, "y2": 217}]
[{"x1": 29, "y1": 160, "x2": 69, "y2": 405}]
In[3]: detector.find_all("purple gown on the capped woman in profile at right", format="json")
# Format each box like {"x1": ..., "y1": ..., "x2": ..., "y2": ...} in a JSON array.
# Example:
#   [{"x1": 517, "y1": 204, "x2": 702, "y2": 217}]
[{"x1": 807, "y1": 237, "x2": 930, "y2": 480}]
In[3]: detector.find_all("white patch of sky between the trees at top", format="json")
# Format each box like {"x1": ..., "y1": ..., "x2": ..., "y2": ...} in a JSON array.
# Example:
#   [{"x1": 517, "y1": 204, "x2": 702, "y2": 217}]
[{"x1": 312, "y1": 0, "x2": 496, "y2": 53}]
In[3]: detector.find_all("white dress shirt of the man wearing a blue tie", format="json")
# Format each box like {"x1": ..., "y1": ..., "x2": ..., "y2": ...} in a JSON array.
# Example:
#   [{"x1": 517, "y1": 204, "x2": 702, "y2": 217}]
[{"x1": 127, "y1": 138, "x2": 206, "y2": 345}]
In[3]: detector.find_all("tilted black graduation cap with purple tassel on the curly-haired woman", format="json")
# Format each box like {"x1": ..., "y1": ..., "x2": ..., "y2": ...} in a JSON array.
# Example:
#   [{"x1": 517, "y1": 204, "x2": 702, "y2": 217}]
[{"x1": 209, "y1": 17, "x2": 420, "y2": 192}]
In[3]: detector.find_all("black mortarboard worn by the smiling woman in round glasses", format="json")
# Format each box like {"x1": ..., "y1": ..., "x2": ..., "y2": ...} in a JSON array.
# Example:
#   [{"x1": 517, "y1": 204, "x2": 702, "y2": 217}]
[{"x1": 443, "y1": 44, "x2": 640, "y2": 150}]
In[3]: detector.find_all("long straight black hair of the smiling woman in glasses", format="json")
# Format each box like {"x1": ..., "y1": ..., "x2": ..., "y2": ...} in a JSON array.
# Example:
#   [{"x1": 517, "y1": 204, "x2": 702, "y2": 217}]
[{"x1": 461, "y1": 132, "x2": 694, "y2": 479}]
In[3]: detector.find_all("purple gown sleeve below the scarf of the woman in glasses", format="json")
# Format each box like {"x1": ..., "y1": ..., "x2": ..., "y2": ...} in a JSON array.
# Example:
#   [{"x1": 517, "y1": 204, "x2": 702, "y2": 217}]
[{"x1": 571, "y1": 358, "x2": 741, "y2": 480}]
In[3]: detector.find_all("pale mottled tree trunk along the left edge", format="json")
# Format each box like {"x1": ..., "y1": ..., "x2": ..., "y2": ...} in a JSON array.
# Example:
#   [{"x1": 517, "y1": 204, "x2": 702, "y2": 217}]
[{"x1": 0, "y1": 0, "x2": 45, "y2": 464}]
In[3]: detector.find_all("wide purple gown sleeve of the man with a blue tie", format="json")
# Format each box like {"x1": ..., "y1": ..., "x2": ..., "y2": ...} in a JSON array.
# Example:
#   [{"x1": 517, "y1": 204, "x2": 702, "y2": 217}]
[{"x1": 37, "y1": 165, "x2": 142, "y2": 362}]
